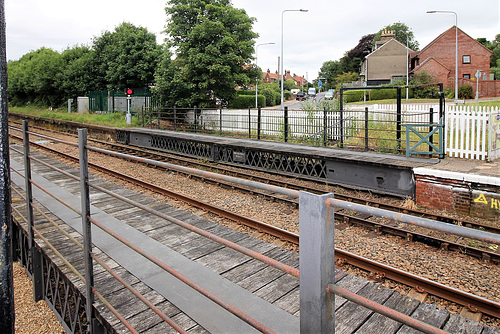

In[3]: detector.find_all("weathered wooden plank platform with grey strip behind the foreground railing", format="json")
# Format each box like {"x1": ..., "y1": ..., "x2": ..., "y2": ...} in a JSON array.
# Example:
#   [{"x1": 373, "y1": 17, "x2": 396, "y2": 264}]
[{"x1": 11, "y1": 147, "x2": 500, "y2": 334}]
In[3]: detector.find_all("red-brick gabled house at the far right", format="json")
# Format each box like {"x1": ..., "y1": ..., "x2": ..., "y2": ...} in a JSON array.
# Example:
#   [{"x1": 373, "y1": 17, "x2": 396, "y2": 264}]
[{"x1": 410, "y1": 26, "x2": 500, "y2": 97}]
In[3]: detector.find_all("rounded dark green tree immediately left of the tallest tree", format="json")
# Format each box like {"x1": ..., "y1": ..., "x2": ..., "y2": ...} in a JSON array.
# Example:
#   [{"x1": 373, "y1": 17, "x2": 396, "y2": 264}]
[{"x1": 90, "y1": 22, "x2": 161, "y2": 90}]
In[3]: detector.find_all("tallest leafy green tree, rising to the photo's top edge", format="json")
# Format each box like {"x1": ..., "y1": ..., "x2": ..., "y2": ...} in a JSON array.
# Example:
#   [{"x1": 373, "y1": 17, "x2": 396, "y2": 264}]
[{"x1": 166, "y1": 0, "x2": 258, "y2": 107}]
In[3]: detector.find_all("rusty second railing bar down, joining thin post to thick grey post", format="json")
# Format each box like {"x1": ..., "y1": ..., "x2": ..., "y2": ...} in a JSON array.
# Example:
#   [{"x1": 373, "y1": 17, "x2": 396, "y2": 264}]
[{"x1": 89, "y1": 184, "x2": 300, "y2": 277}]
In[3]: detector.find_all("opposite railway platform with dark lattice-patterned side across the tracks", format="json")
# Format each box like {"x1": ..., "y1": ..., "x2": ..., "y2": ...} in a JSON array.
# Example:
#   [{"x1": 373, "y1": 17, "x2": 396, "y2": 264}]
[{"x1": 117, "y1": 128, "x2": 438, "y2": 197}]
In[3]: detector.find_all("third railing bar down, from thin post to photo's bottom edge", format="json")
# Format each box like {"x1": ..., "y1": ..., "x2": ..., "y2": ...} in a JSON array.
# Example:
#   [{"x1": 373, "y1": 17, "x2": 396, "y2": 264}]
[{"x1": 88, "y1": 217, "x2": 275, "y2": 334}]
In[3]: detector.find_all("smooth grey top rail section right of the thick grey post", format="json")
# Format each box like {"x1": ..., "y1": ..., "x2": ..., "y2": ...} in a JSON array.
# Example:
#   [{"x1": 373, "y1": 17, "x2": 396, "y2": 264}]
[{"x1": 327, "y1": 198, "x2": 500, "y2": 245}]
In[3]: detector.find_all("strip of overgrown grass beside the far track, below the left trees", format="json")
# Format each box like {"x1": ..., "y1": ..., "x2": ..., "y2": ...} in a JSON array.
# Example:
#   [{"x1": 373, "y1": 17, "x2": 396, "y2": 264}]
[{"x1": 9, "y1": 106, "x2": 140, "y2": 128}]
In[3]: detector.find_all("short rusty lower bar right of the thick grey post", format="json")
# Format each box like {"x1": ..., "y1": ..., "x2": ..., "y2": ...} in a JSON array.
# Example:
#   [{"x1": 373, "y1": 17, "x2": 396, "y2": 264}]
[{"x1": 326, "y1": 284, "x2": 447, "y2": 334}]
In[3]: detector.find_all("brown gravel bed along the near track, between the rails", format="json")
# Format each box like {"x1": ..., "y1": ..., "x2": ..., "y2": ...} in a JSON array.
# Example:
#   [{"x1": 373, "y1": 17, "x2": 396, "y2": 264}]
[{"x1": 8, "y1": 129, "x2": 500, "y2": 329}]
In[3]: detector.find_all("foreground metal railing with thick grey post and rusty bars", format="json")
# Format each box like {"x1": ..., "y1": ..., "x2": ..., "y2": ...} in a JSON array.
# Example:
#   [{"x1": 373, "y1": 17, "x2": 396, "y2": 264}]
[{"x1": 8, "y1": 121, "x2": 500, "y2": 333}]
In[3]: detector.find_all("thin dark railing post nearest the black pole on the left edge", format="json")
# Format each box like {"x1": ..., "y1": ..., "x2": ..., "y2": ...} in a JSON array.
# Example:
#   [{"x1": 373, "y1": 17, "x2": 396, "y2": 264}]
[{"x1": 23, "y1": 120, "x2": 43, "y2": 302}]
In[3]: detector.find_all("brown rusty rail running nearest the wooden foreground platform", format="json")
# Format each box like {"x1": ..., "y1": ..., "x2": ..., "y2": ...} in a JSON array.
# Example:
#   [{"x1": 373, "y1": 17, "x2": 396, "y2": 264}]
[{"x1": 5, "y1": 124, "x2": 500, "y2": 318}]
